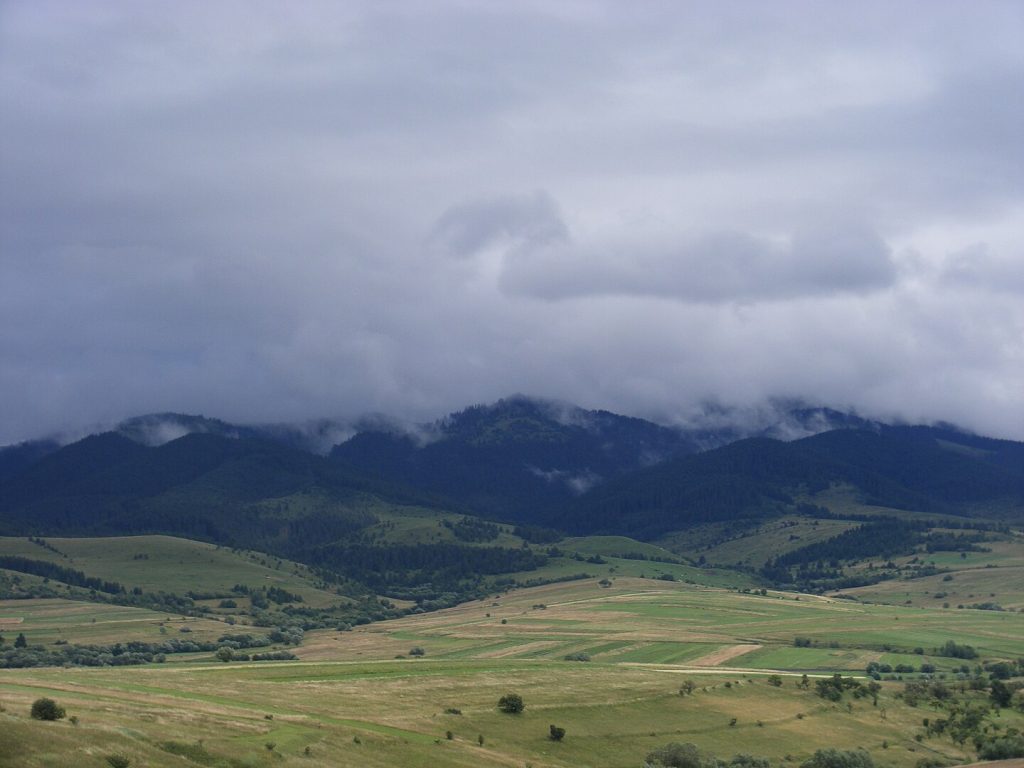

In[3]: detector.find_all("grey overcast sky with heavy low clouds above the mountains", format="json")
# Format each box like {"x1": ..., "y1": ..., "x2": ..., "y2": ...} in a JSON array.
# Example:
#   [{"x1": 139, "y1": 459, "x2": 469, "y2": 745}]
[{"x1": 0, "y1": 0, "x2": 1024, "y2": 443}]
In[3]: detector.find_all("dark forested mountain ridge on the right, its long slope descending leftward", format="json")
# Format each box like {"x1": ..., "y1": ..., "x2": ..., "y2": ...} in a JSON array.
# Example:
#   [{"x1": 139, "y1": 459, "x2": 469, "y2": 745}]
[{"x1": 564, "y1": 426, "x2": 1024, "y2": 539}]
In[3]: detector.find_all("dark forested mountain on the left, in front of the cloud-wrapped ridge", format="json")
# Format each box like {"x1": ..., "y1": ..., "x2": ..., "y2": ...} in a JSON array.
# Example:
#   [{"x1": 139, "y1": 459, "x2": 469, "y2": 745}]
[{"x1": 0, "y1": 432, "x2": 436, "y2": 546}]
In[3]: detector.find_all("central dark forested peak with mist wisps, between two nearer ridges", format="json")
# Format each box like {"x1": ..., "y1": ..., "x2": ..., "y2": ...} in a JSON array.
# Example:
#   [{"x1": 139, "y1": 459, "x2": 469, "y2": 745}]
[{"x1": 331, "y1": 397, "x2": 696, "y2": 522}]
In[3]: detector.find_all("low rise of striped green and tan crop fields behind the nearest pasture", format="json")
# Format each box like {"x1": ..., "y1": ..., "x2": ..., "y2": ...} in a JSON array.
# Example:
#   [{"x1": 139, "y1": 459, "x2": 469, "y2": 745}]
[{"x1": 299, "y1": 578, "x2": 1024, "y2": 671}]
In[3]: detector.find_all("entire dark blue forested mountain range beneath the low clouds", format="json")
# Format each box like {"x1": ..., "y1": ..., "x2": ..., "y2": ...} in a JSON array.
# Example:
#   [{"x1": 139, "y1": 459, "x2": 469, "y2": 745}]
[{"x1": 0, "y1": 396, "x2": 1024, "y2": 598}]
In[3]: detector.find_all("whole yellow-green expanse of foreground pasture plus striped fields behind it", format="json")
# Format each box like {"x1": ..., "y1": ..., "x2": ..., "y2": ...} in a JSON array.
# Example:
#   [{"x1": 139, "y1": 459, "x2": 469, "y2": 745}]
[{"x1": 0, "y1": 578, "x2": 1024, "y2": 768}]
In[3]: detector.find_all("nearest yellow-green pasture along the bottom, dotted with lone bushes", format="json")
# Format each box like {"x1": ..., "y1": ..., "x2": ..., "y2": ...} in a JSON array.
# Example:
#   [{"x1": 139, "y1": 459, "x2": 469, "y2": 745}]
[{"x1": 6, "y1": 659, "x2": 1024, "y2": 768}]
